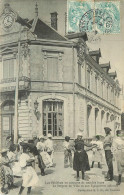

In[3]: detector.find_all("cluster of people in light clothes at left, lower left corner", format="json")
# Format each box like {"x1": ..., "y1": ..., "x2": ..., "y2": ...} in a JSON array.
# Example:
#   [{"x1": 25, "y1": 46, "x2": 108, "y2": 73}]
[{"x1": 0, "y1": 134, "x2": 54, "y2": 194}]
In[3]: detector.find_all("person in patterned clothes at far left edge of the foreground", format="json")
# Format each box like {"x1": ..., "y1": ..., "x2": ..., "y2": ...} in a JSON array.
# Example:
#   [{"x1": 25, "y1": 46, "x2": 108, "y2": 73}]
[{"x1": 0, "y1": 149, "x2": 13, "y2": 194}]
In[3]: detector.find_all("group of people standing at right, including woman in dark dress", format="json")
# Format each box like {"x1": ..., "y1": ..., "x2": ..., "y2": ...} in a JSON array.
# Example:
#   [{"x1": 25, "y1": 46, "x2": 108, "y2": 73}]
[{"x1": 64, "y1": 127, "x2": 124, "y2": 185}]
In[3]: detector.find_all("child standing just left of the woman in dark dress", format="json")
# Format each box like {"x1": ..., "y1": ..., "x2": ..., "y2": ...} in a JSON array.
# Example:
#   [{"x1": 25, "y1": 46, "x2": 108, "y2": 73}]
[{"x1": 63, "y1": 136, "x2": 72, "y2": 168}]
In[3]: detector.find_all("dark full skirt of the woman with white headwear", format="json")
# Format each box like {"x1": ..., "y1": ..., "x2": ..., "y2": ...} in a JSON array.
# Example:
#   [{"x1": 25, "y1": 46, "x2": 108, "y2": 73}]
[{"x1": 73, "y1": 150, "x2": 90, "y2": 172}]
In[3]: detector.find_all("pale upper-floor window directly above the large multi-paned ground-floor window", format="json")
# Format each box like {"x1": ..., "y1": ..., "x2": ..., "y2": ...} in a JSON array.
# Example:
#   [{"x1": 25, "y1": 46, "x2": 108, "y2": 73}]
[{"x1": 47, "y1": 57, "x2": 58, "y2": 81}]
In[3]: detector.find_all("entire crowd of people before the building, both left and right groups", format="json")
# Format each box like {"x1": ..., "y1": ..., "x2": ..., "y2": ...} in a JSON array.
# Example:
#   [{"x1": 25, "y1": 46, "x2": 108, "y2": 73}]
[{"x1": 0, "y1": 127, "x2": 124, "y2": 194}]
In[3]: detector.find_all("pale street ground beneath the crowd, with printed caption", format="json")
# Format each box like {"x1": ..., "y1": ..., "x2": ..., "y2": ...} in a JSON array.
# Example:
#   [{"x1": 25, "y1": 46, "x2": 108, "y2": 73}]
[{"x1": 0, "y1": 152, "x2": 124, "y2": 195}]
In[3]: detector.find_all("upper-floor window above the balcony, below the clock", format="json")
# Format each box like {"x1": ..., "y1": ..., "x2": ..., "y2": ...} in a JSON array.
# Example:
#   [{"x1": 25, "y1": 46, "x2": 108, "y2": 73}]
[{"x1": 3, "y1": 59, "x2": 14, "y2": 79}]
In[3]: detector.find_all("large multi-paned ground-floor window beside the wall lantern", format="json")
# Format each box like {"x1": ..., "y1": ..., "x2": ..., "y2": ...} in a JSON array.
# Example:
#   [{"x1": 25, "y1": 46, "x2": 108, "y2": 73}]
[{"x1": 43, "y1": 100, "x2": 64, "y2": 137}]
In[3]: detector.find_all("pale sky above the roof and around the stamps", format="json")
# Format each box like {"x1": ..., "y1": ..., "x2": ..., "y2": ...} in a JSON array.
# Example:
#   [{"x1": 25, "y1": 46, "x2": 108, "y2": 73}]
[{"x1": 0, "y1": 0, "x2": 124, "y2": 86}]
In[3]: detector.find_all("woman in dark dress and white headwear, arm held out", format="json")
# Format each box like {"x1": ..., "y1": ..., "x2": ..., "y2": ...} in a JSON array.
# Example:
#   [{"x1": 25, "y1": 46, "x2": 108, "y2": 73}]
[{"x1": 73, "y1": 133, "x2": 95, "y2": 179}]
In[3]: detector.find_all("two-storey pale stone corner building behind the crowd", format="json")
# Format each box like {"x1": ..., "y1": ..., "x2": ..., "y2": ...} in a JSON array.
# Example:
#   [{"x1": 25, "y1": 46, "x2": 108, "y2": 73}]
[{"x1": 0, "y1": 5, "x2": 121, "y2": 150}]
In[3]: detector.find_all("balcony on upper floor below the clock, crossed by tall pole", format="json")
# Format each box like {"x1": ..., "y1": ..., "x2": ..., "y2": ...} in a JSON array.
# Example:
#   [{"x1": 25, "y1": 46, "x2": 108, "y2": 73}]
[{"x1": 0, "y1": 76, "x2": 30, "y2": 92}]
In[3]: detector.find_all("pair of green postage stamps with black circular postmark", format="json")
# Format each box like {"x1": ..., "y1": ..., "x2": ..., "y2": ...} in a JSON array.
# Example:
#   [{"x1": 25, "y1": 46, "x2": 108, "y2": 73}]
[{"x1": 67, "y1": 0, "x2": 120, "y2": 34}]
